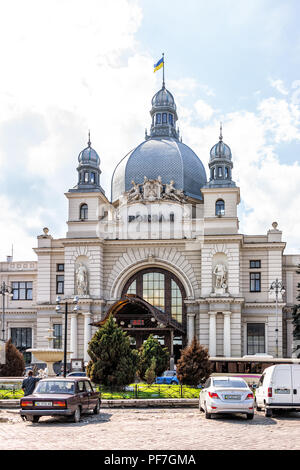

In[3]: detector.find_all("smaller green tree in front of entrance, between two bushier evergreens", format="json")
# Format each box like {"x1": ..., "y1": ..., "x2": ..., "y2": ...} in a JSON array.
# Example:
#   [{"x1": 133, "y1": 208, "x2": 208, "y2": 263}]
[{"x1": 139, "y1": 334, "x2": 169, "y2": 379}]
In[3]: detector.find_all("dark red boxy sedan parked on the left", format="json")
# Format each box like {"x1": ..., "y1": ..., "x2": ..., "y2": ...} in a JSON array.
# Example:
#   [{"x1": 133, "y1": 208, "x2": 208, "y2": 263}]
[{"x1": 20, "y1": 377, "x2": 101, "y2": 423}]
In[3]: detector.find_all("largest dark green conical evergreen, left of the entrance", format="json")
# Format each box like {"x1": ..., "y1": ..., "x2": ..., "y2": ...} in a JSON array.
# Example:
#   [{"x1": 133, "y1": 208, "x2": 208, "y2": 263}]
[{"x1": 87, "y1": 315, "x2": 139, "y2": 387}]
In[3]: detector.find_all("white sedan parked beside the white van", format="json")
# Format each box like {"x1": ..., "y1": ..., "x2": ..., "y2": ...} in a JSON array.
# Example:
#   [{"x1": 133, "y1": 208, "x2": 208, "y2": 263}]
[{"x1": 199, "y1": 376, "x2": 254, "y2": 419}]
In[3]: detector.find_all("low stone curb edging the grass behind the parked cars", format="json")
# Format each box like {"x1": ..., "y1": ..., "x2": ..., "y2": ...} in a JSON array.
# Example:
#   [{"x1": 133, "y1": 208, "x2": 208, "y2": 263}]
[{"x1": 0, "y1": 398, "x2": 198, "y2": 410}]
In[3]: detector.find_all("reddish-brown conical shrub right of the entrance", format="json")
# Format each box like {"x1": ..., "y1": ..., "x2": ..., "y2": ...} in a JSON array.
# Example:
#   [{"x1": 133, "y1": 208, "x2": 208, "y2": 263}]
[{"x1": 176, "y1": 338, "x2": 211, "y2": 385}]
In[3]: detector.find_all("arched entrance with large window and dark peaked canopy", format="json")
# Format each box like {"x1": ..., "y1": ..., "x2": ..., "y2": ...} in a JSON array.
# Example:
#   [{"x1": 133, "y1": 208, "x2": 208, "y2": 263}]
[{"x1": 97, "y1": 267, "x2": 186, "y2": 366}]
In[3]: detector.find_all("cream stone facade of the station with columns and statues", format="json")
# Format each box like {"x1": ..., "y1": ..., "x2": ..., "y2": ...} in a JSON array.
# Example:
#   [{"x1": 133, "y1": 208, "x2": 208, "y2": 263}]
[{"x1": 0, "y1": 84, "x2": 300, "y2": 362}]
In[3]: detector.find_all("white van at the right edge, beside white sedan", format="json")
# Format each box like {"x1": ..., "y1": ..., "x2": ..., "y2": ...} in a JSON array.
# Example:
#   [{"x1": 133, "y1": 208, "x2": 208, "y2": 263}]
[{"x1": 255, "y1": 364, "x2": 300, "y2": 416}]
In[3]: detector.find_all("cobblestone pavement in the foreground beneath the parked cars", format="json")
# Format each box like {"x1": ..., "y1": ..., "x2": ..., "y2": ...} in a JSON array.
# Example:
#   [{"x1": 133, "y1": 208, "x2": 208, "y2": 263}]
[{"x1": 0, "y1": 408, "x2": 300, "y2": 450}]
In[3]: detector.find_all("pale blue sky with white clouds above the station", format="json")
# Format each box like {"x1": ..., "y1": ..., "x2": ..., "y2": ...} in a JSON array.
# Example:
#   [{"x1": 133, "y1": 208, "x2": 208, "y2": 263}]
[{"x1": 0, "y1": 0, "x2": 300, "y2": 261}]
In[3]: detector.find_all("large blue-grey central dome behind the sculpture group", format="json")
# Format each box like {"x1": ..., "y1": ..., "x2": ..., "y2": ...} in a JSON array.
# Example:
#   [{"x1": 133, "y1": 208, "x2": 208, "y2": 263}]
[{"x1": 111, "y1": 137, "x2": 206, "y2": 202}]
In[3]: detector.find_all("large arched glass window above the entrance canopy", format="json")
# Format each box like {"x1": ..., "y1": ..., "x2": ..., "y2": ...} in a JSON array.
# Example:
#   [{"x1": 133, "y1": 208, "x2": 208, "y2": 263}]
[{"x1": 122, "y1": 268, "x2": 185, "y2": 324}]
